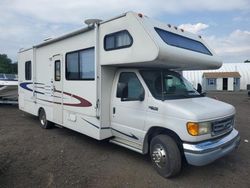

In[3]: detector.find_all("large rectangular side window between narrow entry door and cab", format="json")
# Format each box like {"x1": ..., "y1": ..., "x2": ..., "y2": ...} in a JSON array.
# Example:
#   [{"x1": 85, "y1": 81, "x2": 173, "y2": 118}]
[{"x1": 66, "y1": 48, "x2": 95, "y2": 80}]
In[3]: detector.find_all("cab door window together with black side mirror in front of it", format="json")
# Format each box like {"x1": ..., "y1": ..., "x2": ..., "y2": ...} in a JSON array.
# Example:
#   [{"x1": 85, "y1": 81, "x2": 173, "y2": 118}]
[{"x1": 116, "y1": 72, "x2": 144, "y2": 101}]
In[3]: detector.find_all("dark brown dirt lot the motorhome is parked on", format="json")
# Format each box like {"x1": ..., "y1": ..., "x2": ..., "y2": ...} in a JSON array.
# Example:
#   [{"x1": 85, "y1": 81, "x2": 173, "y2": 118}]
[{"x1": 0, "y1": 92, "x2": 250, "y2": 188}]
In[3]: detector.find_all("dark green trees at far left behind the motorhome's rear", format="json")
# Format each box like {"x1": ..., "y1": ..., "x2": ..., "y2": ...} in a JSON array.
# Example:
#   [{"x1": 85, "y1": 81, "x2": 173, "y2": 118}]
[{"x1": 0, "y1": 54, "x2": 17, "y2": 74}]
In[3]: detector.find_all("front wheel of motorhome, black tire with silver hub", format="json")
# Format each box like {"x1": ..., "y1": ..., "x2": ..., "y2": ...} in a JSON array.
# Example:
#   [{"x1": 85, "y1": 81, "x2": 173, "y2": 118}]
[{"x1": 150, "y1": 134, "x2": 182, "y2": 178}]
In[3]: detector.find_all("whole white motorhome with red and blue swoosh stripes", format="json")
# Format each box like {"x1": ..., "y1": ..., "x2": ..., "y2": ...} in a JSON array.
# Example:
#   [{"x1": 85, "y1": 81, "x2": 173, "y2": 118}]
[{"x1": 18, "y1": 12, "x2": 240, "y2": 177}]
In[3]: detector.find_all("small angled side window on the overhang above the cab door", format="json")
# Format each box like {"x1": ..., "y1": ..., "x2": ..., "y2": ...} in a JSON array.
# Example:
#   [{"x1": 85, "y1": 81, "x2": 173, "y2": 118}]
[{"x1": 104, "y1": 30, "x2": 133, "y2": 51}]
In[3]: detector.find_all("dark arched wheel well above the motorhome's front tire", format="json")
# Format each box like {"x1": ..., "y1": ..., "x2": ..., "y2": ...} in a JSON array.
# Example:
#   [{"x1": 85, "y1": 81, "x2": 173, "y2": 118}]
[{"x1": 143, "y1": 127, "x2": 183, "y2": 154}]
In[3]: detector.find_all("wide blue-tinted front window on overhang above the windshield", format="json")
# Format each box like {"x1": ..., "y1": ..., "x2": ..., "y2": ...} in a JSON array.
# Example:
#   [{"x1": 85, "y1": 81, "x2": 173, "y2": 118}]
[{"x1": 155, "y1": 28, "x2": 212, "y2": 55}]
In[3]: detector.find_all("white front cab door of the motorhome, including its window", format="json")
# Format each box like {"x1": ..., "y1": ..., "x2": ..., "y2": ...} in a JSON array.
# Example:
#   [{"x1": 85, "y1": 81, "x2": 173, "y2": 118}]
[{"x1": 111, "y1": 72, "x2": 147, "y2": 143}]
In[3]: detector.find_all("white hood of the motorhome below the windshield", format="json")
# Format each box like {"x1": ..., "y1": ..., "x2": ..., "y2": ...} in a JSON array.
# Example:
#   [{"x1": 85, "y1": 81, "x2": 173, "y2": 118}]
[{"x1": 164, "y1": 97, "x2": 235, "y2": 121}]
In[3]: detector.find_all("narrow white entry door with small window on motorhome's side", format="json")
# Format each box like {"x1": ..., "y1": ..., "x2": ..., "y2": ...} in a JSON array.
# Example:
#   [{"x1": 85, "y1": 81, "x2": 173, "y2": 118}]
[{"x1": 52, "y1": 55, "x2": 63, "y2": 125}]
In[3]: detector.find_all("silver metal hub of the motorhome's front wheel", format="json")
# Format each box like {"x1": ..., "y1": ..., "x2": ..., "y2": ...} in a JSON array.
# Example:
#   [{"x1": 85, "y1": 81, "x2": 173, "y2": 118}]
[{"x1": 152, "y1": 144, "x2": 167, "y2": 168}]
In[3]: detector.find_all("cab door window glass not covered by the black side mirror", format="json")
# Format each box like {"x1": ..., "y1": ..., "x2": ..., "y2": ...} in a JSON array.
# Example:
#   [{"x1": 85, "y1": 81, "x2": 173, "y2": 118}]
[{"x1": 118, "y1": 72, "x2": 144, "y2": 101}]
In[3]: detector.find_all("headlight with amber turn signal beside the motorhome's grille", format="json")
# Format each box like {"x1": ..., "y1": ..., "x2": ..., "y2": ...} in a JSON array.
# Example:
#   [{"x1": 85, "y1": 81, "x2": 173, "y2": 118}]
[{"x1": 187, "y1": 122, "x2": 211, "y2": 136}]
